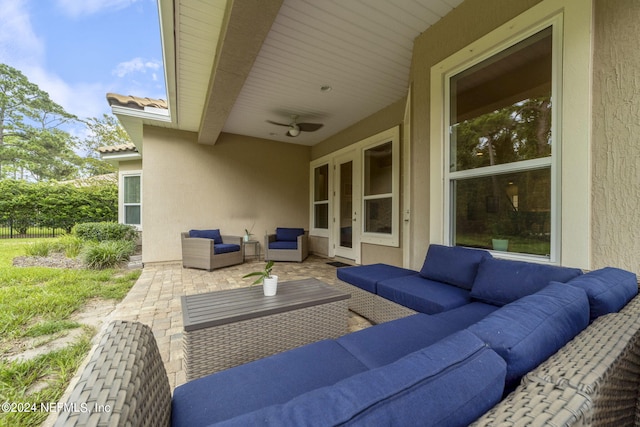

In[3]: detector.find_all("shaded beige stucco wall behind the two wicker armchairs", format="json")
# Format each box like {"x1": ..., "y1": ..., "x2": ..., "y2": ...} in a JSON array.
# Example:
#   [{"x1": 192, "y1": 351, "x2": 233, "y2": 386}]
[{"x1": 142, "y1": 127, "x2": 310, "y2": 263}]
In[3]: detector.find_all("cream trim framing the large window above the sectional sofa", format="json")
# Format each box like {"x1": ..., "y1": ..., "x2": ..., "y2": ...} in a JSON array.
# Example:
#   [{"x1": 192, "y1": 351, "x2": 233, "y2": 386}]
[{"x1": 429, "y1": 0, "x2": 592, "y2": 268}]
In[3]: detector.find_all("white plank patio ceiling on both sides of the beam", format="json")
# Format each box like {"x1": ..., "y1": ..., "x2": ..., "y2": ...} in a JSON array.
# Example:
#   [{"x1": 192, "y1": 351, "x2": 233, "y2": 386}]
[{"x1": 161, "y1": 0, "x2": 463, "y2": 145}]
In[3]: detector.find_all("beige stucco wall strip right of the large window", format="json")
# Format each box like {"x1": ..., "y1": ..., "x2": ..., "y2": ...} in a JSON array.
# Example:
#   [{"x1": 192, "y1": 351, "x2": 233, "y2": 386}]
[{"x1": 592, "y1": 0, "x2": 640, "y2": 273}]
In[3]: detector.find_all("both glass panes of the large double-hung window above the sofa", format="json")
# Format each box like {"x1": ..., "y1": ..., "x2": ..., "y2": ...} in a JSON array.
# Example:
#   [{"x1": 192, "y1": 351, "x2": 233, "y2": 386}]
[{"x1": 445, "y1": 26, "x2": 558, "y2": 258}]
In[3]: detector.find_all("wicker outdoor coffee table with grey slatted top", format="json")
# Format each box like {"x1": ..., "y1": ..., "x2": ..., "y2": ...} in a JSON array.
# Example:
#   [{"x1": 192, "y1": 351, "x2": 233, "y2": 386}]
[{"x1": 182, "y1": 279, "x2": 350, "y2": 381}]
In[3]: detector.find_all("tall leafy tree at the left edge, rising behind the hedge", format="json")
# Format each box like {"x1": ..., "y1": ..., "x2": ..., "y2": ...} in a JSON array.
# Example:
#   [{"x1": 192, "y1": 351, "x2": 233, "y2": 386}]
[{"x1": 0, "y1": 64, "x2": 82, "y2": 181}]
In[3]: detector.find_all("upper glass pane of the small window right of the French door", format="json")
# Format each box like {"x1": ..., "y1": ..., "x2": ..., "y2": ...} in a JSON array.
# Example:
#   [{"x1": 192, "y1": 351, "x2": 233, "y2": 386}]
[{"x1": 364, "y1": 141, "x2": 393, "y2": 196}]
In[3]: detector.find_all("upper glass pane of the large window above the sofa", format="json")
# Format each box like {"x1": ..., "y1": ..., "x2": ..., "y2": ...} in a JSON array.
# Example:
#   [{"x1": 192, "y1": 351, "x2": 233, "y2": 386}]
[{"x1": 449, "y1": 28, "x2": 552, "y2": 172}]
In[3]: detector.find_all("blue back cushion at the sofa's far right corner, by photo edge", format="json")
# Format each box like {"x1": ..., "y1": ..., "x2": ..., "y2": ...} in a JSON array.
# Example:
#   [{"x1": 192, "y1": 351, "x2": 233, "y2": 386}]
[{"x1": 567, "y1": 267, "x2": 638, "y2": 321}]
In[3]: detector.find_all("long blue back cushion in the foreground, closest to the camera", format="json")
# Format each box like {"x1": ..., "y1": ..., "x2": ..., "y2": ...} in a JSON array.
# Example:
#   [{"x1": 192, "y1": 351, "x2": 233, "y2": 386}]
[{"x1": 212, "y1": 331, "x2": 505, "y2": 427}]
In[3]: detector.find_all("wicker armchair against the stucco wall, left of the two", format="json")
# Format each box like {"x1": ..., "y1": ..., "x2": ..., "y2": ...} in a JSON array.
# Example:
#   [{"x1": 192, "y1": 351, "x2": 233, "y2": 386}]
[{"x1": 181, "y1": 233, "x2": 244, "y2": 271}]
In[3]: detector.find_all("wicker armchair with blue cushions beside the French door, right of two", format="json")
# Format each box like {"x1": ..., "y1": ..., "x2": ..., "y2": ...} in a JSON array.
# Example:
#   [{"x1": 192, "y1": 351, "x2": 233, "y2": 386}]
[{"x1": 264, "y1": 227, "x2": 309, "y2": 262}]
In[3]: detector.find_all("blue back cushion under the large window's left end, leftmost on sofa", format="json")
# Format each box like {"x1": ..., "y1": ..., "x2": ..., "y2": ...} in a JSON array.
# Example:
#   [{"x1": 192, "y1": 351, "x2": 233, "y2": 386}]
[{"x1": 420, "y1": 245, "x2": 491, "y2": 290}]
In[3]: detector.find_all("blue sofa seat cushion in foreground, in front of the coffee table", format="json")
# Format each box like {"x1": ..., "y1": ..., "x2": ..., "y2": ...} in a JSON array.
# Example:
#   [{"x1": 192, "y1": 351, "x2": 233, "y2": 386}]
[{"x1": 171, "y1": 340, "x2": 367, "y2": 427}]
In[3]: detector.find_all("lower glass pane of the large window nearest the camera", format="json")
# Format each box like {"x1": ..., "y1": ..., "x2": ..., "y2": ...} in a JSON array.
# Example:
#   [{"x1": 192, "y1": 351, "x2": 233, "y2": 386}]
[{"x1": 453, "y1": 168, "x2": 551, "y2": 256}]
